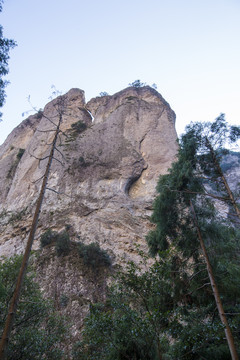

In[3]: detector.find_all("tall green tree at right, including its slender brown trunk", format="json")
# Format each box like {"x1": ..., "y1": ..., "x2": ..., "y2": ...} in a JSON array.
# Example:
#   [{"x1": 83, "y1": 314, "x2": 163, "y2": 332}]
[{"x1": 147, "y1": 115, "x2": 240, "y2": 359}]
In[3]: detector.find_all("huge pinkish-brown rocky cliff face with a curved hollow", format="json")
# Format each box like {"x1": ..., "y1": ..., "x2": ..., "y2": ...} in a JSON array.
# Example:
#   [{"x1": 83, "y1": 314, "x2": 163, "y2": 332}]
[{"x1": 0, "y1": 87, "x2": 177, "y2": 338}]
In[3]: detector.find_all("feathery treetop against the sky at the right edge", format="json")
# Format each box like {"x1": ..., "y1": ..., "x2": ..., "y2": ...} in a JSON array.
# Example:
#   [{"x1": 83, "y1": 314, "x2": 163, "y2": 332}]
[{"x1": 183, "y1": 114, "x2": 240, "y2": 220}]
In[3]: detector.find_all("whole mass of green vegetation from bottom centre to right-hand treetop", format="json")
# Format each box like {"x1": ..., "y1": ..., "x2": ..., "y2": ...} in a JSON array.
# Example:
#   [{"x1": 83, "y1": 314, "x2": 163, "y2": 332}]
[{"x1": 74, "y1": 115, "x2": 240, "y2": 360}]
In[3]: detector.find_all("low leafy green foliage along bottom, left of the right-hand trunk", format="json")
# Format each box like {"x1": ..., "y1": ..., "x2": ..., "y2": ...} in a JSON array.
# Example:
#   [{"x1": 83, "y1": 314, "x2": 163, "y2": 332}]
[{"x1": 73, "y1": 240, "x2": 240, "y2": 360}]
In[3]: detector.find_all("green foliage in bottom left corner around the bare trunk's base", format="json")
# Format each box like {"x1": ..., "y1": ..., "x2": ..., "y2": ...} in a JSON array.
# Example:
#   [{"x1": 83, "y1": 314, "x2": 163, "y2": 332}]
[{"x1": 0, "y1": 256, "x2": 67, "y2": 360}]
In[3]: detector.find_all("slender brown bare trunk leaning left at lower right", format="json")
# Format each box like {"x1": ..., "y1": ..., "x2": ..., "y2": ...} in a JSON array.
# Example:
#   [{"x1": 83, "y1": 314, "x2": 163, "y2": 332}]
[{"x1": 190, "y1": 200, "x2": 238, "y2": 360}]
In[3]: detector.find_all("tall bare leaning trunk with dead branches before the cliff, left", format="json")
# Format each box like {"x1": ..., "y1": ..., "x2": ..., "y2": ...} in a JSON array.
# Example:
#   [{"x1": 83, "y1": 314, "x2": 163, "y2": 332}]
[{"x1": 0, "y1": 112, "x2": 62, "y2": 360}]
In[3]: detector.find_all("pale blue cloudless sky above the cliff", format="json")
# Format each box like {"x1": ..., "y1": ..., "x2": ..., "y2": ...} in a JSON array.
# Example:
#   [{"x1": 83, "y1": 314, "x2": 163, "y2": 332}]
[{"x1": 0, "y1": 0, "x2": 240, "y2": 144}]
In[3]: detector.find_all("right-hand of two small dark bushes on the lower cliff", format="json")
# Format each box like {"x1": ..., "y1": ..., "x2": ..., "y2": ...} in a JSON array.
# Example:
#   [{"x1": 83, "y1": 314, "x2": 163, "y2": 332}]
[{"x1": 78, "y1": 243, "x2": 112, "y2": 267}]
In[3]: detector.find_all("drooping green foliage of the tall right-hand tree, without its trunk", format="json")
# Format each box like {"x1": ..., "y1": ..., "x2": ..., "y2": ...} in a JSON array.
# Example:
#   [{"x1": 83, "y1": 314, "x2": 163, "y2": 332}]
[{"x1": 144, "y1": 115, "x2": 240, "y2": 359}]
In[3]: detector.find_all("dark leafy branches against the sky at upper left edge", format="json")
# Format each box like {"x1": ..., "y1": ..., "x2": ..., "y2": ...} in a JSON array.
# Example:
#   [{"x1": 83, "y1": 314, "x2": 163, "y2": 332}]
[{"x1": 0, "y1": 0, "x2": 16, "y2": 119}]
